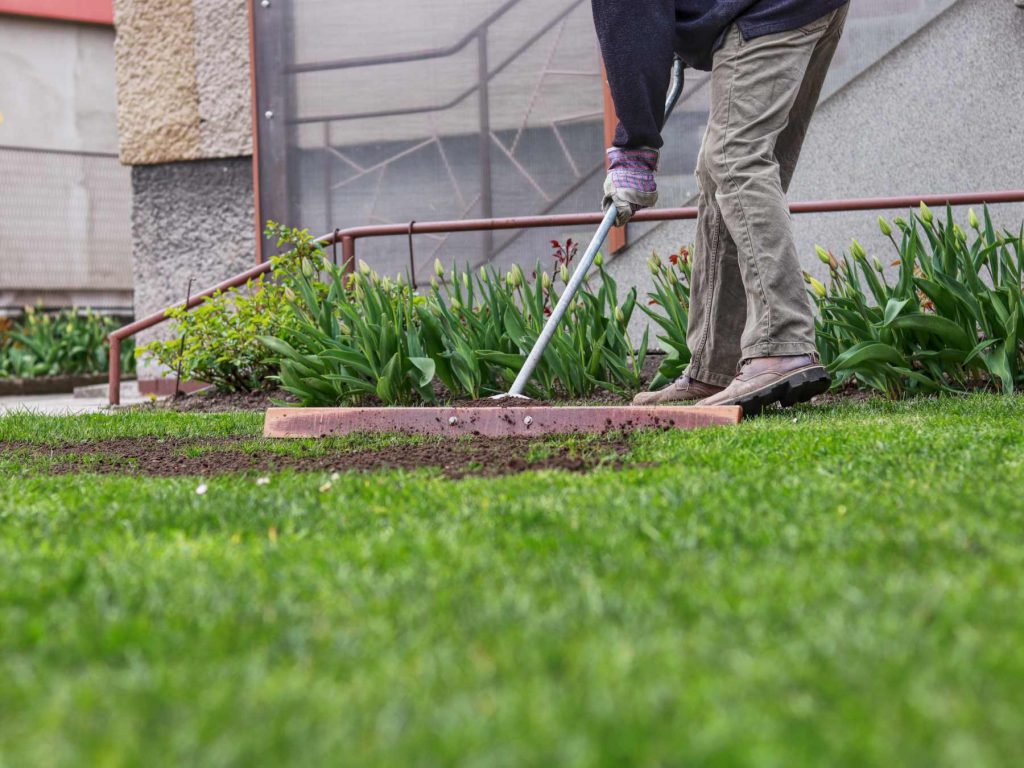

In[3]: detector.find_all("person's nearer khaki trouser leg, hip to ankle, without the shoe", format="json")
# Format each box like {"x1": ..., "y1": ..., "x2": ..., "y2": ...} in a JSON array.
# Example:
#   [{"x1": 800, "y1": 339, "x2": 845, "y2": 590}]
[{"x1": 703, "y1": 8, "x2": 835, "y2": 358}]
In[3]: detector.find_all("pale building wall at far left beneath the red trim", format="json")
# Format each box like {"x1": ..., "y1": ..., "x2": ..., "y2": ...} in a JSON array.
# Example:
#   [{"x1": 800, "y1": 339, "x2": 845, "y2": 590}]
[{"x1": 0, "y1": 14, "x2": 132, "y2": 309}]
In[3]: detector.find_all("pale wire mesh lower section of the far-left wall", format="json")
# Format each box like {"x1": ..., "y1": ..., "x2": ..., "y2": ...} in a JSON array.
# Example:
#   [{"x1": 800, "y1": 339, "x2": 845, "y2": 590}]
[{"x1": 0, "y1": 147, "x2": 132, "y2": 311}]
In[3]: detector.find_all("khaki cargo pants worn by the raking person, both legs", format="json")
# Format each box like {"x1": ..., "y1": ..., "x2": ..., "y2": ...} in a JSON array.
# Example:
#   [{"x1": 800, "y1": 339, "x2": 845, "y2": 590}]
[{"x1": 687, "y1": 5, "x2": 849, "y2": 386}]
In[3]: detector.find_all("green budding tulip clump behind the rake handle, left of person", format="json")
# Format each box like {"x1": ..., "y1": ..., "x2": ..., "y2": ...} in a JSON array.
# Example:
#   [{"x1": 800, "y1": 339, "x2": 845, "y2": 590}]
[{"x1": 260, "y1": 231, "x2": 646, "y2": 406}]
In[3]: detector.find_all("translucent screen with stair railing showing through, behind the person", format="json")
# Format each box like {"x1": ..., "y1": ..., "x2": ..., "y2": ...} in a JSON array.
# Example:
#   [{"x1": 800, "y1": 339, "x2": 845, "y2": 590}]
[{"x1": 255, "y1": 0, "x2": 954, "y2": 276}]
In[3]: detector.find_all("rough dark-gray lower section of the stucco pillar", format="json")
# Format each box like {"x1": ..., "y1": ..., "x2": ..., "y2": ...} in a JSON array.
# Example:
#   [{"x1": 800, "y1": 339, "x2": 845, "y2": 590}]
[{"x1": 132, "y1": 158, "x2": 256, "y2": 378}]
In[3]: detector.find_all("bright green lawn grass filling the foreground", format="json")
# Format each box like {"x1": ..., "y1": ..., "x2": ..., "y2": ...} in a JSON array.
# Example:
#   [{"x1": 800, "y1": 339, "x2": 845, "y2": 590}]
[{"x1": 0, "y1": 396, "x2": 1024, "y2": 767}]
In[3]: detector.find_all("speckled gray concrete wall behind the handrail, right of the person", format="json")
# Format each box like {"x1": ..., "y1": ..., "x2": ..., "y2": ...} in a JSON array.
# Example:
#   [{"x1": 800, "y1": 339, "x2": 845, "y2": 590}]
[{"x1": 610, "y1": 0, "x2": 1024, "y2": 346}]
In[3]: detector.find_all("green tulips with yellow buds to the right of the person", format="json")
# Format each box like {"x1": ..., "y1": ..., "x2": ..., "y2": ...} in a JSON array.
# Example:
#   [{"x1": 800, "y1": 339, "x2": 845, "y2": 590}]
[{"x1": 806, "y1": 205, "x2": 1024, "y2": 396}]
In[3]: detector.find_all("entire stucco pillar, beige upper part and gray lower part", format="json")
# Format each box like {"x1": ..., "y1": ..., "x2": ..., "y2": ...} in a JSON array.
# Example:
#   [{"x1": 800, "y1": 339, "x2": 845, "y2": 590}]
[{"x1": 115, "y1": 0, "x2": 256, "y2": 378}]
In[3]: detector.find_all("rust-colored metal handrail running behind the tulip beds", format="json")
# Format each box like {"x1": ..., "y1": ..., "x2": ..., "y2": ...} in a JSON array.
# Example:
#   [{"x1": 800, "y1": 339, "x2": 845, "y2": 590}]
[{"x1": 108, "y1": 189, "x2": 1024, "y2": 406}]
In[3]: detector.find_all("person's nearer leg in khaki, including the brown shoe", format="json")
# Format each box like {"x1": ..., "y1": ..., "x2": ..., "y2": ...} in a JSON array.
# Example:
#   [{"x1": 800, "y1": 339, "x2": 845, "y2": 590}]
[{"x1": 699, "y1": 7, "x2": 847, "y2": 413}]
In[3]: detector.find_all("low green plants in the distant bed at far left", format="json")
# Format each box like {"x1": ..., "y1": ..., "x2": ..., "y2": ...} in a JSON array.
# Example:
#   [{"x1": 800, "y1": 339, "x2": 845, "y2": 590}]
[{"x1": 0, "y1": 307, "x2": 135, "y2": 378}]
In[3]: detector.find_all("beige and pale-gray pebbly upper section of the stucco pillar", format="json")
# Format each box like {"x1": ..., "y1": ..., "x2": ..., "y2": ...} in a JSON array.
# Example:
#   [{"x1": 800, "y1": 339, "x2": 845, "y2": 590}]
[{"x1": 115, "y1": 0, "x2": 252, "y2": 165}]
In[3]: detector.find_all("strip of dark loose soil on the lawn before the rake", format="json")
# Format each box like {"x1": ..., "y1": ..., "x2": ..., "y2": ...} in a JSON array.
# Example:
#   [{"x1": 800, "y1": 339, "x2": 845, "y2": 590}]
[{"x1": 0, "y1": 434, "x2": 630, "y2": 478}]
